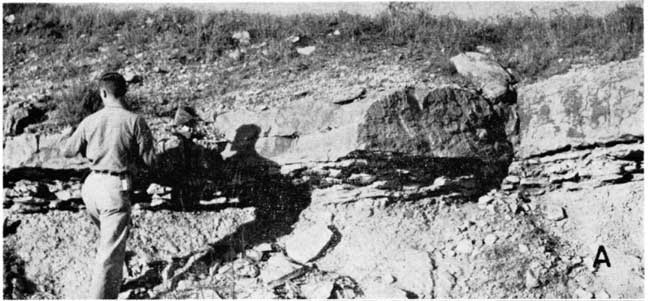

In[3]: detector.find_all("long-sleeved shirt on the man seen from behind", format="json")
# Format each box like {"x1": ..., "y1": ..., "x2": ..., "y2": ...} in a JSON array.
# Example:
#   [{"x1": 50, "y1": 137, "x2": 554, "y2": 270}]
[{"x1": 63, "y1": 106, "x2": 155, "y2": 172}]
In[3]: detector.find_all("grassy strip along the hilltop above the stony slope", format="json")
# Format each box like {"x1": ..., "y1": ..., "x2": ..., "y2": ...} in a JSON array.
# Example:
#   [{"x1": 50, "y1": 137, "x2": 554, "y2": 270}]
[{"x1": 4, "y1": 3, "x2": 643, "y2": 78}]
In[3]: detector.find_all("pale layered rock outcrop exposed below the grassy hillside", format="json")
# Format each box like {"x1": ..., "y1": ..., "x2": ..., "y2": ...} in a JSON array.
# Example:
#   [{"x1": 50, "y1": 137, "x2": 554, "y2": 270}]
[{"x1": 5, "y1": 53, "x2": 644, "y2": 298}]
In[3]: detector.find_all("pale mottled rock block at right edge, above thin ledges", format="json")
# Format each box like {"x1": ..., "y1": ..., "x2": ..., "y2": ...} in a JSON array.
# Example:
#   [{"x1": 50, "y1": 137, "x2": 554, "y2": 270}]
[{"x1": 516, "y1": 57, "x2": 643, "y2": 158}]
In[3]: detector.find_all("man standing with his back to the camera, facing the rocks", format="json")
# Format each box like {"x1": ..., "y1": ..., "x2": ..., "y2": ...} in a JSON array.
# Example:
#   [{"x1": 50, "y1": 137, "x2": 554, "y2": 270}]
[{"x1": 63, "y1": 72, "x2": 155, "y2": 299}]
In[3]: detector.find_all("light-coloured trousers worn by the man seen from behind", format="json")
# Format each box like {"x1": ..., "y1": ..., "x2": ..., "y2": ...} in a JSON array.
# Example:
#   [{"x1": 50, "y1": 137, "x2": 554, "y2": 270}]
[{"x1": 81, "y1": 172, "x2": 131, "y2": 299}]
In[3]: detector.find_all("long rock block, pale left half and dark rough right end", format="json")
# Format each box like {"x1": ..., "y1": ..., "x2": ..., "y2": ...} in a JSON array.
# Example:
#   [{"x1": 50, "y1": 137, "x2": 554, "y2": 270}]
[{"x1": 215, "y1": 85, "x2": 512, "y2": 170}]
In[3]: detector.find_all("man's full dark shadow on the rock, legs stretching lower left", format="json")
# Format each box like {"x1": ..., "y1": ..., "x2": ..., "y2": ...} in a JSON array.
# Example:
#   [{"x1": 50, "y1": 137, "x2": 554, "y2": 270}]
[{"x1": 122, "y1": 124, "x2": 311, "y2": 291}]
